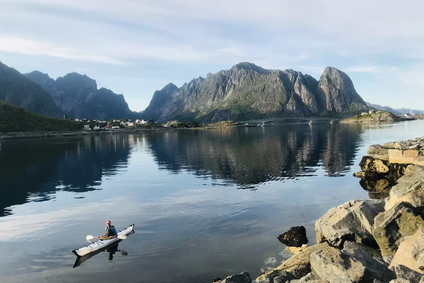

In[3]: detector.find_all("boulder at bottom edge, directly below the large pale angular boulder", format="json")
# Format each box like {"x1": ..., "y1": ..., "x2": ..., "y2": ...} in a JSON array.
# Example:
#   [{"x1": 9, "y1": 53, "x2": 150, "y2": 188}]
[{"x1": 311, "y1": 247, "x2": 394, "y2": 283}]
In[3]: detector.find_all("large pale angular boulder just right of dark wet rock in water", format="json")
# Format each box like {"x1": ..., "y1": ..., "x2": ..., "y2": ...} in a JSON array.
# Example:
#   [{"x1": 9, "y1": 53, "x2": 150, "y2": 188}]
[{"x1": 315, "y1": 200, "x2": 384, "y2": 247}]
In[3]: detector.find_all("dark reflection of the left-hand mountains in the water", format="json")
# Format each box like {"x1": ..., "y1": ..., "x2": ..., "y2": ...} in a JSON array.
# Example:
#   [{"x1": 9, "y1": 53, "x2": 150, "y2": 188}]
[{"x1": 0, "y1": 135, "x2": 130, "y2": 216}]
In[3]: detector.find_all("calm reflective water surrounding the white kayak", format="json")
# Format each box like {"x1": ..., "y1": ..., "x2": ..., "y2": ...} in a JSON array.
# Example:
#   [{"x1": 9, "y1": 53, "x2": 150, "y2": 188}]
[{"x1": 0, "y1": 121, "x2": 424, "y2": 283}]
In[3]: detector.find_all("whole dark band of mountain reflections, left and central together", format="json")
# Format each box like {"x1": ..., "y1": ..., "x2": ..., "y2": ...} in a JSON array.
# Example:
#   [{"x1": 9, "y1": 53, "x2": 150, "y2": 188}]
[{"x1": 0, "y1": 125, "x2": 363, "y2": 216}]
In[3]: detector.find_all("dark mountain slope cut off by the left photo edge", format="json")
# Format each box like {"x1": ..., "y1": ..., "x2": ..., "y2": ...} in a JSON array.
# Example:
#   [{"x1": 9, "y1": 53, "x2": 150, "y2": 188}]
[{"x1": 0, "y1": 62, "x2": 63, "y2": 117}]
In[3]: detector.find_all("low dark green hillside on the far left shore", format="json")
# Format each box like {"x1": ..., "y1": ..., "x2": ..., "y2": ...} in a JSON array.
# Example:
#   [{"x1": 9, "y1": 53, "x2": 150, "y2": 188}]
[{"x1": 0, "y1": 101, "x2": 82, "y2": 132}]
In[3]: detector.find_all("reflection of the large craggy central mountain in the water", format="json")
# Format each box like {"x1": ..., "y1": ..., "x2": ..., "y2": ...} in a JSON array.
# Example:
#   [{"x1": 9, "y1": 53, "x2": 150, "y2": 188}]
[{"x1": 148, "y1": 125, "x2": 363, "y2": 188}]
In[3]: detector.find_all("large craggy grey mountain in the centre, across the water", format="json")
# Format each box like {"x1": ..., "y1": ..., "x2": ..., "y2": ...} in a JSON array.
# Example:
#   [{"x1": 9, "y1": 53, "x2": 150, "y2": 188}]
[{"x1": 143, "y1": 62, "x2": 368, "y2": 122}]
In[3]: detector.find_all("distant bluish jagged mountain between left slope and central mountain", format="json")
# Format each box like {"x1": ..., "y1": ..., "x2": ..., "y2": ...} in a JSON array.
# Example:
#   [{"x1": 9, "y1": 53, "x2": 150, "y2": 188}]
[{"x1": 25, "y1": 71, "x2": 138, "y2": 120}]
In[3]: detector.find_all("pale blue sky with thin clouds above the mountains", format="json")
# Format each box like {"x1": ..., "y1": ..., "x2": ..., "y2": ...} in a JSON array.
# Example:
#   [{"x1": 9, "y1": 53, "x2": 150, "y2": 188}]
[{"x1": 0, "y1": 0, "x2": 424, "y2": 111}]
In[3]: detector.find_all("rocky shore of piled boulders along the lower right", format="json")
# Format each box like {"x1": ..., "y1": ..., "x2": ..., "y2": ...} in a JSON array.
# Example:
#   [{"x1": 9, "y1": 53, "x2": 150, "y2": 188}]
[{"x1": 214, "y1": 138, "x2": 424, "y2": 283}]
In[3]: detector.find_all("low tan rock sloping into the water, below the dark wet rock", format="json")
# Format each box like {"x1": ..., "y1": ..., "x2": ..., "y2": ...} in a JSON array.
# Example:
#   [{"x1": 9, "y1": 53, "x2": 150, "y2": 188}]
[{"x1": 256, "y1": 243, "x2": 329, "y2": 281}]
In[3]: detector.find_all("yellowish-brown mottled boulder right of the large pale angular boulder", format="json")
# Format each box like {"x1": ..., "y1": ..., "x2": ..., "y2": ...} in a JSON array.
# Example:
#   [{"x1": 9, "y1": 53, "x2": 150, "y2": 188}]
[{"x1": 373, "y1": 203, "x2": 424, "y2": 261}]
